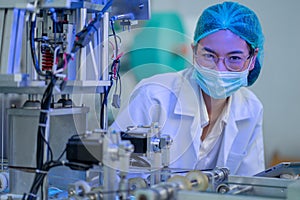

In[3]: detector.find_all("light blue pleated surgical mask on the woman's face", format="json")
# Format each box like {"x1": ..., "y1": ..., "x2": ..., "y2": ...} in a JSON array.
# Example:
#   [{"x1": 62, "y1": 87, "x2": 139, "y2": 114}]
[{"x1": 192, "y1": 62, "x2": 251, "y2": 99}]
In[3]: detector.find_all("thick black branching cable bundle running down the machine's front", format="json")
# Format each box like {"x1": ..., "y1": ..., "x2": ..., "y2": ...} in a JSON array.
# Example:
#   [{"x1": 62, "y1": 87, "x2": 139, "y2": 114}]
[{"x1": 23, "y1": 0, "x2": 113, "y2": 200}]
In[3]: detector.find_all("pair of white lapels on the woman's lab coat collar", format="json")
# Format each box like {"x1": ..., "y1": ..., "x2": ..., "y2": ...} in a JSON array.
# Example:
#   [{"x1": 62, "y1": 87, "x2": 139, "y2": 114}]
[{"x1": 174, "y1": 69, "x2": 254, "y2": 169}]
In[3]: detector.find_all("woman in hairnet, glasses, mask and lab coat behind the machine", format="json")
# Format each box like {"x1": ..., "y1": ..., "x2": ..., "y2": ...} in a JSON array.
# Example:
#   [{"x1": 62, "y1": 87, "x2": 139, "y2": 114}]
[{"x1": 111, "y1": 2, "x2": 265, "y2": 176}]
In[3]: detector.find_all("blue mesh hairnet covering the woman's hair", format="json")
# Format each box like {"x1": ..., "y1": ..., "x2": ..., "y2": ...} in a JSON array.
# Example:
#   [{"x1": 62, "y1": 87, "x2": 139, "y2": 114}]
[{"x1": 194, "y1": 2, "x2": 264, "y2": 86}]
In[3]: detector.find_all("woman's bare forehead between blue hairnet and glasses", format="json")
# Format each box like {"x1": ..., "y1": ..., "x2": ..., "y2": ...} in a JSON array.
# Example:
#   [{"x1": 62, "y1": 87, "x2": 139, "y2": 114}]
[{"x1": 198, "y1": 30, "x2": 248, "y2": 53}]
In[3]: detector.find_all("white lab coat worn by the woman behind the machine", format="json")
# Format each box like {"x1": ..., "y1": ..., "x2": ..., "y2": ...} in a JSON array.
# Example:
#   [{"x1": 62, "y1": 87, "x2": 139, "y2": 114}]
[{"x1": 111, "y1": 67, "x2": 265, "y2": 176}]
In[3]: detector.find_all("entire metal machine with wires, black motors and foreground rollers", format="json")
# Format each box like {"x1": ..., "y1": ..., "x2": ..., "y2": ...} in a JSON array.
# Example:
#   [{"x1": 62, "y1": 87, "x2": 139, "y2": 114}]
[{"x1": 0, "y1": 0, "x2": 300, "y2": 200}]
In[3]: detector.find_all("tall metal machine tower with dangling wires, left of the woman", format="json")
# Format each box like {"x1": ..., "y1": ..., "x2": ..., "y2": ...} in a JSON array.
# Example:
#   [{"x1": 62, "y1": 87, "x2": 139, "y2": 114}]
[{"x1": 0, "y1": 0, "x2": 150, "y2": 199}]
